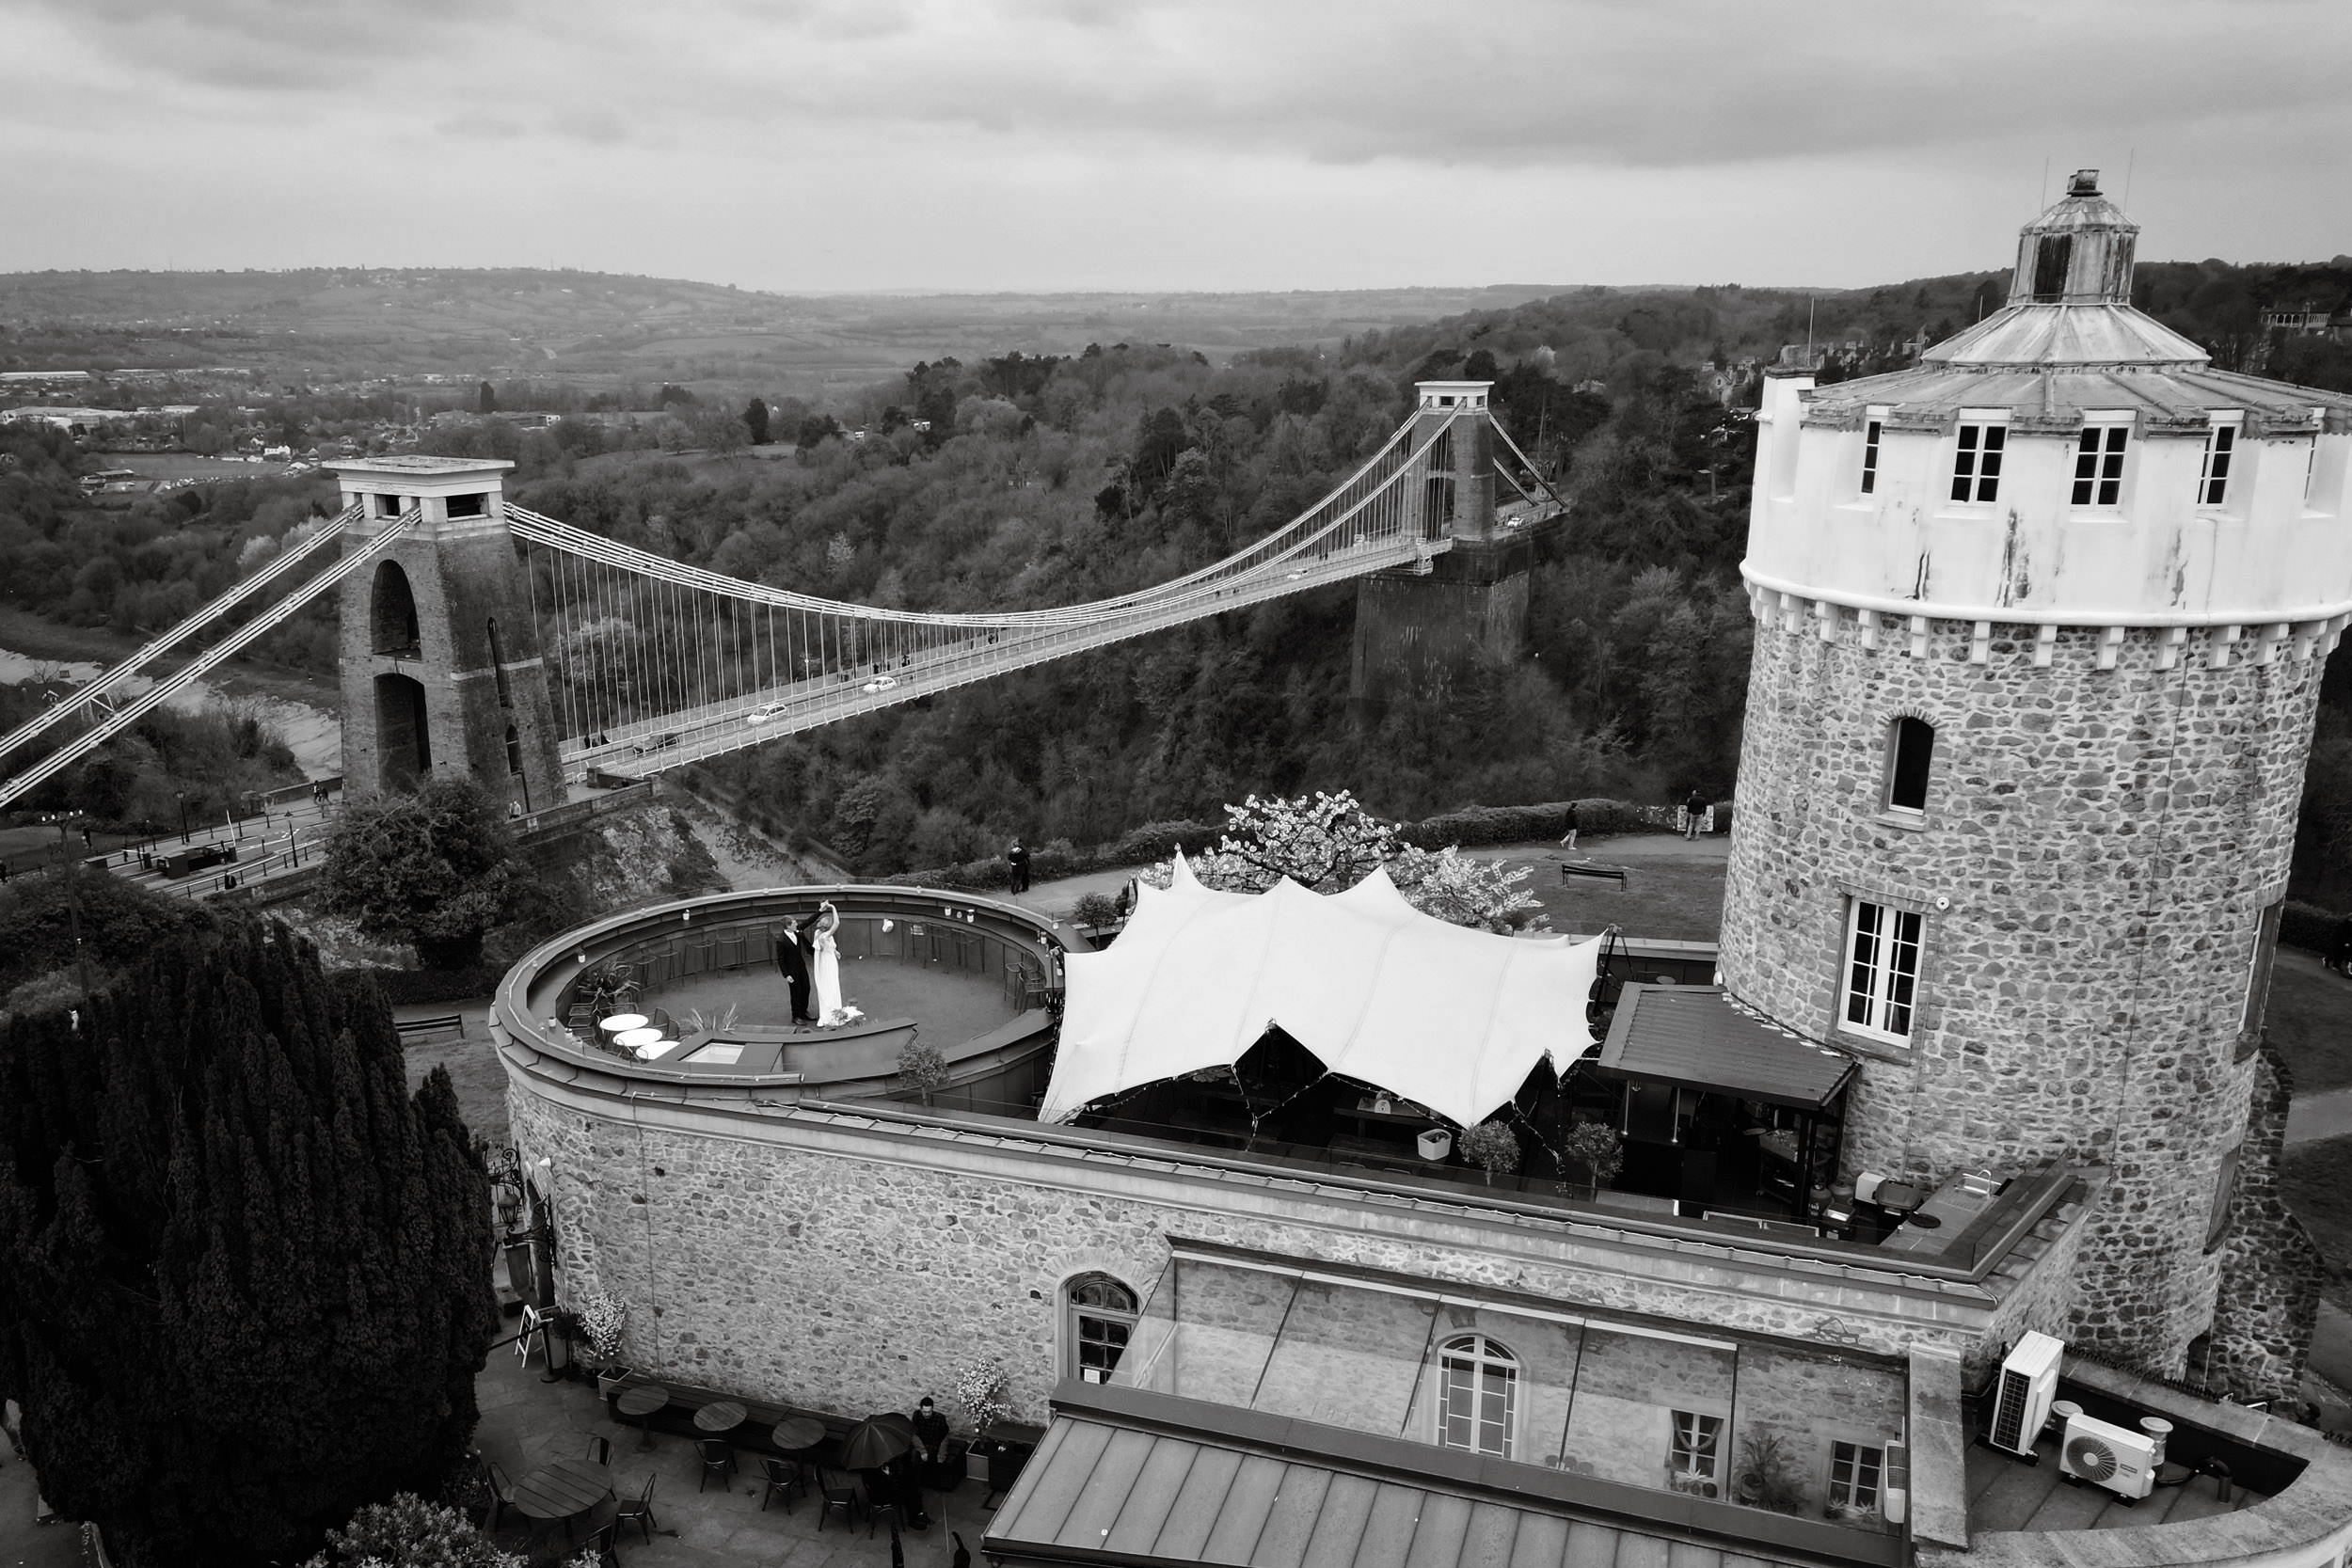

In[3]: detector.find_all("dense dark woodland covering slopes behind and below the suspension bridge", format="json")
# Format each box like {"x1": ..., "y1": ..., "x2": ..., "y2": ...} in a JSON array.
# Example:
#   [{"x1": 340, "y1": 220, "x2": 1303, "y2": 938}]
[{"x1": 0, "y1": 259, "x2": 2352, "y2": 884}]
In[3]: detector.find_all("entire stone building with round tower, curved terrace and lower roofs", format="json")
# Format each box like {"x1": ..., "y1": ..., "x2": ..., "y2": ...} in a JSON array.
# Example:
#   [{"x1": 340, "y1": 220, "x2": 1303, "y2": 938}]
[{"x1": 492, "y1": 179, "x2": 2352, "y2": 1568}]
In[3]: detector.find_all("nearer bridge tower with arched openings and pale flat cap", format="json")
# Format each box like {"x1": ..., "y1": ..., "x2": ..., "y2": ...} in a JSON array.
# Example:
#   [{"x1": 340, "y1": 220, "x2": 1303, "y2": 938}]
[{"x1": 329, "y1": 456, "x2": 564, "y2": 811}]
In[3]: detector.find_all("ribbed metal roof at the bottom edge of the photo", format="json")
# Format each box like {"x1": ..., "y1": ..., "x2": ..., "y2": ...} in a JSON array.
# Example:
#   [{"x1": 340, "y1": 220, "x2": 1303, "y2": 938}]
[{"x1": 981, "y1": 1416, "x2": 1809, "y2": 1568}]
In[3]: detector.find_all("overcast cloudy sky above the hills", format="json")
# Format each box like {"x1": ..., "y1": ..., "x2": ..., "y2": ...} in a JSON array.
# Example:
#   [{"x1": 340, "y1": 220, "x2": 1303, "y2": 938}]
[{"x1": 0, "y1": 0, "x2": 2352, "y2": 292}]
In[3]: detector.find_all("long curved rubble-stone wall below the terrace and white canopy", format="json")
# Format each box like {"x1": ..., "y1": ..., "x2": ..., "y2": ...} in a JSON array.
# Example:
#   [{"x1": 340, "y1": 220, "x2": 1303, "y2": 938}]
[{"x1": 508, "y1": 1081, "x2": 2070, "y2": 1420}]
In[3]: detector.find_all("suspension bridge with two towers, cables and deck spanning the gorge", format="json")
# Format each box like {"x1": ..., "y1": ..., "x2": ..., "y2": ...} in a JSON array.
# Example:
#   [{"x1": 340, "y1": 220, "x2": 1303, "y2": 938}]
[{"x1": 0, "y1": 383, "x2": 1565, "y2": 888}]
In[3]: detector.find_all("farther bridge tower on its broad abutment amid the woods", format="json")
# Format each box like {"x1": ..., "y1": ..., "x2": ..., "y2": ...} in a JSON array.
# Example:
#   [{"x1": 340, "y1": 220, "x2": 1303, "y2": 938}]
[{"x1": 1348, "y1": 381, "x2": 1534, "y2": 720}]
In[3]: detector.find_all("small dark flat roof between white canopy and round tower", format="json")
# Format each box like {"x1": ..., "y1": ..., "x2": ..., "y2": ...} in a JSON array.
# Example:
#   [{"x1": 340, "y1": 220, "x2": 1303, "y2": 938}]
[{"x1": 1599, "y1": 985, "x2": 1858, "y2": 1110}]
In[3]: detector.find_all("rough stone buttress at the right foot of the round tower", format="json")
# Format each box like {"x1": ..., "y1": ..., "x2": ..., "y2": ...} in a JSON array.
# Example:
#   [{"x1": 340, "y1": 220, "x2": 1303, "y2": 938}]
[{"x1": 2190, "y1": 1046, "x2": 2322, "y2": 1402}]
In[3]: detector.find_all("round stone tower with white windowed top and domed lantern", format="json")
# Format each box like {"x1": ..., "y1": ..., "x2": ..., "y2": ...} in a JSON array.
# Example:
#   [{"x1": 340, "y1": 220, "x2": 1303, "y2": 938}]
[{"x1": 1722, "y1": 171, "x2": 2352, "y2": 1389}]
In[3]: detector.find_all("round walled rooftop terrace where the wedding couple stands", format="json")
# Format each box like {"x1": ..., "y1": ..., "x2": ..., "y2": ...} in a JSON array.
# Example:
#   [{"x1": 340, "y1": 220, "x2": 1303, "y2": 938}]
[{"x1": 492, "y1": 884, "x2": 1089, "y2": 1117}]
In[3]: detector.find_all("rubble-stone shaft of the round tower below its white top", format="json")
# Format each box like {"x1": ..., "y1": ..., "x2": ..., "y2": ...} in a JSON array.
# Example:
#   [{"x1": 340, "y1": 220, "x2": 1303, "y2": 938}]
[{"x1": 1722, "y1": 609, "x2": 2324, "y2": 1373}]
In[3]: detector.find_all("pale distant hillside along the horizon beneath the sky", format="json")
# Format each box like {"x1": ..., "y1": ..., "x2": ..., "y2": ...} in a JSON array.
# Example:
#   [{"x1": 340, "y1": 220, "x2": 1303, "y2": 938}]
[{"x1": 0, "y1": 268, "x2": 1590, "y2": 395}]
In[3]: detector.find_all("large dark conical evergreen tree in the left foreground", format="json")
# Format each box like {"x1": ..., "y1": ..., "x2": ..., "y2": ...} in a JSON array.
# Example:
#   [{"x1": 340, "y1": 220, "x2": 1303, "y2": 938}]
[{"x1": 0, "y1": 922, "x2": 499, "y2": 1568}]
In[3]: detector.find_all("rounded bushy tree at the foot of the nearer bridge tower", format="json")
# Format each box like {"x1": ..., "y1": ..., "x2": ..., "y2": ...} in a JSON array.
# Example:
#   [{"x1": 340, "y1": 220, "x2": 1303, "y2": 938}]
[{"x1": 325, "y1": 778, "x2": 532, "y2": 969}]
